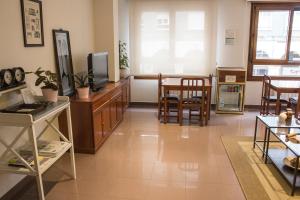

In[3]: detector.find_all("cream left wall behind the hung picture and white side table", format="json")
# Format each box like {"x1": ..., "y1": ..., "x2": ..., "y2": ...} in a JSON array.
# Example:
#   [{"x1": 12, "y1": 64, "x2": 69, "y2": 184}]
[{"x1": 0, "y1": 0, "x2": 94, "y2": 196}]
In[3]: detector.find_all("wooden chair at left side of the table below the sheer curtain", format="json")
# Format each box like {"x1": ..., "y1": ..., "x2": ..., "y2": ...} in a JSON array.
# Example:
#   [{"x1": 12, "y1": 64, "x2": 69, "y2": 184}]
[{"x1": 158, "y1": 73, "x2": 179, "y2": 123}]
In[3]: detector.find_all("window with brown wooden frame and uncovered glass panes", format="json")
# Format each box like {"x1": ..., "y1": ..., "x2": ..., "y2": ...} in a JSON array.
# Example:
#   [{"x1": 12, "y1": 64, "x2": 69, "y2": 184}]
[{"x1": 248, "y1": 3, "x2": 300, "y2": 80}]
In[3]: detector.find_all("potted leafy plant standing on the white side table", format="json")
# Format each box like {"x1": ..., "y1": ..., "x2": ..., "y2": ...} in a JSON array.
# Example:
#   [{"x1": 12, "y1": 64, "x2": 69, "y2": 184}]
[{"x1": 27, "y1": 67, "x2": 58, "y2": 102}]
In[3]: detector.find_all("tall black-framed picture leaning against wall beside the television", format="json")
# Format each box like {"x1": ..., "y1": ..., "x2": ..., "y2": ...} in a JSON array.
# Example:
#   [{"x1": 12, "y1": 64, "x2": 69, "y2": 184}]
[{"x1": 52, "y1": 30, "x2": 75, "y2": 96}]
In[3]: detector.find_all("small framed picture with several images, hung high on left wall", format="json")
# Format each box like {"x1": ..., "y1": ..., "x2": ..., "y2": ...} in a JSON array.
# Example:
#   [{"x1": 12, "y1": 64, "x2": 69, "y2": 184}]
[{"x1": 21, "y1": 0, "x2": 44, "y2": 47}]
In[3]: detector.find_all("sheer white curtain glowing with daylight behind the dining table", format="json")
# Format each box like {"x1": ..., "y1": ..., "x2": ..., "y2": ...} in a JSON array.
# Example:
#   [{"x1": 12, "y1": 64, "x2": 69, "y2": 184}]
[{"x1": 130, "y1": 0, "x2": 215, "y2": 75}]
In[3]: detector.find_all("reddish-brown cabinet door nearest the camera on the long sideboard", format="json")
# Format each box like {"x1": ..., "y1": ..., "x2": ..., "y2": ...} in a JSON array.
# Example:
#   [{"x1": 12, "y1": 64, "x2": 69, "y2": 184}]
[{"x1": 93, "y1": 110, "x2": 103, "y2": 147}]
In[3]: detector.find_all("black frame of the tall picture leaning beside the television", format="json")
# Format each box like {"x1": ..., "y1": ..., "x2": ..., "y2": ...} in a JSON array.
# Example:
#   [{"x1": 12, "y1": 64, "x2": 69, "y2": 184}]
[{"x1": 52, "y1": 29, "x2": 75, "y2": 96}]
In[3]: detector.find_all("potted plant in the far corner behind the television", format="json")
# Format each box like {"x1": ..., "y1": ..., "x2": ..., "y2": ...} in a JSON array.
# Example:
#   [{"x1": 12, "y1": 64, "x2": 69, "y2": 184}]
[{"x1": 119, "y1": 41, "x2": 130, "y2": 78}]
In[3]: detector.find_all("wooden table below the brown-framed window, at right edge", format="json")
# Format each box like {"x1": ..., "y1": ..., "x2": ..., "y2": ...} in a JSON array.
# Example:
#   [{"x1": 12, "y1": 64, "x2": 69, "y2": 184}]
[{"x1": 266, "y1": 80, "x2": 300, "y2": 115}]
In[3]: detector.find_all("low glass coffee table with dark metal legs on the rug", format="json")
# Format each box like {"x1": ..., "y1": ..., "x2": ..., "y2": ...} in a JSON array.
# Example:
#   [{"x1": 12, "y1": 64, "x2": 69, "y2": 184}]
[{"x1": 253, "y1": 116, "x2": 300, "y2": 196}]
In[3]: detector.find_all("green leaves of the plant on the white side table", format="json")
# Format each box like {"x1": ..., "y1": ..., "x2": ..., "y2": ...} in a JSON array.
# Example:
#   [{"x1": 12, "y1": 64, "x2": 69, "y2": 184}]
[{"x1": 26, "y1": 67, "x2": 58, "y2": 90}]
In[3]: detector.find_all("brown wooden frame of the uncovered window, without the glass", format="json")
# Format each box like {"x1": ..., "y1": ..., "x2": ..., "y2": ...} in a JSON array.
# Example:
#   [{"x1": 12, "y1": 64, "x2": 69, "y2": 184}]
[{"x1": 247, "y1": 2, "x2": 300, "y2": 81}]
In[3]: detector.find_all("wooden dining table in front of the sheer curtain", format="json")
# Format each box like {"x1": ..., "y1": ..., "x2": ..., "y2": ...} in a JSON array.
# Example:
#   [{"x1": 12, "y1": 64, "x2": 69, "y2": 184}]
[{"x1": 162, "y1": 78, "x2": 212, "y2": 124}]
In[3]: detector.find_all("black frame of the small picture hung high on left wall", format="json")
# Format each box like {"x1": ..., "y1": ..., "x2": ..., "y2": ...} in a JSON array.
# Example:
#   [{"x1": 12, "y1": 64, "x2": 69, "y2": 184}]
[{"x1": 20, "y1": 0, "x2": 44, "y2": 47}]
